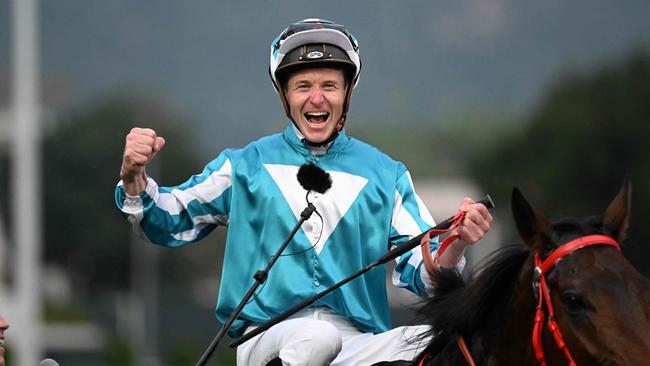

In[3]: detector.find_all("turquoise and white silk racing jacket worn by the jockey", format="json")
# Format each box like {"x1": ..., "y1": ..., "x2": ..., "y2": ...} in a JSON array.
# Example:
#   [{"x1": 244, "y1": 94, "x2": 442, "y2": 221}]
[{"x1": 115, "y1": 124, "x2": 462, "y2": 336}]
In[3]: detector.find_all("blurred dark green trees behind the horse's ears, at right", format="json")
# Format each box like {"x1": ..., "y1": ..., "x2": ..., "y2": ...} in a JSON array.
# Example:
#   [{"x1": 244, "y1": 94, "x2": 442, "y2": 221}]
[{"x1": 467, "y1": 52, "x2": 650, "y2": 275}]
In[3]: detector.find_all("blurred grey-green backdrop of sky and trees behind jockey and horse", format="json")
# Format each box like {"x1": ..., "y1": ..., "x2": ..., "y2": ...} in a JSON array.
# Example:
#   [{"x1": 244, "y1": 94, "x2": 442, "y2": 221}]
[{"x1": 0, "y1": 0, "x2": 650, "y2": 366}]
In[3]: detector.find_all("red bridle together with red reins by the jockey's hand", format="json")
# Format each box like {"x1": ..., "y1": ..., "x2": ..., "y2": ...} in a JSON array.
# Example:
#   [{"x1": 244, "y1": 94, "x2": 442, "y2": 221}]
[{"x1": 418, "y1": 232, "x2": 621, "y2": 366}]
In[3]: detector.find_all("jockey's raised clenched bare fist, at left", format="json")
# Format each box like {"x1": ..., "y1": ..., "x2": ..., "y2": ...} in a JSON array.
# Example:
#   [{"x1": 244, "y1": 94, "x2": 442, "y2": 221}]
[{"x1": 120, "y1": 127, "x2": 165, "y2": 195}]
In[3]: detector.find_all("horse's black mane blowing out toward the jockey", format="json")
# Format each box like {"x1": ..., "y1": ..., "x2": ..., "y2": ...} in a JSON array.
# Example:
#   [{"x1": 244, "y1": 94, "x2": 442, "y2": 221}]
[{"x1": 410, "y1": 245, "x2": 529, "y2": 359}]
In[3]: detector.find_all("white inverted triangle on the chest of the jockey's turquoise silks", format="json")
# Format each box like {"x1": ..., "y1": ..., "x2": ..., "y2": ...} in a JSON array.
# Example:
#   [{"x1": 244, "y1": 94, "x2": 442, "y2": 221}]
[{"x1": 264, "y1": 164, "x2": 368, "y2": 254}]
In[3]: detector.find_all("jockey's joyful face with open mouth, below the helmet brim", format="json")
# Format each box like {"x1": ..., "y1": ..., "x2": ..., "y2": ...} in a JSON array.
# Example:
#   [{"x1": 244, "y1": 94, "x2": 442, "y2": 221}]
[{"x1": 286, "y1": 68, "x2": 346, "y2": 143}]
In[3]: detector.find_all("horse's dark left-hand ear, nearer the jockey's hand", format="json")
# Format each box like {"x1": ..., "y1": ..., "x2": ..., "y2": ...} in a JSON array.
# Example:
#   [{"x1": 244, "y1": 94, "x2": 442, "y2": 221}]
[{"x1": 510, "y1": 187, "x2": 552, "y2": 251}]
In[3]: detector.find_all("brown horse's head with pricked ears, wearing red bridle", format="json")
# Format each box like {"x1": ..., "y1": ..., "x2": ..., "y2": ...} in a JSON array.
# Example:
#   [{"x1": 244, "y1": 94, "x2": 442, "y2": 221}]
[{"x1": 512, "y1": 182, "x2": 650, "y2": 365}]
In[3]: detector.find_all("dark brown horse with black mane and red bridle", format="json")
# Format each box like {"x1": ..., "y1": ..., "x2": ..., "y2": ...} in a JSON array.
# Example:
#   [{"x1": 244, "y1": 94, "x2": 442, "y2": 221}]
[{"x1": 374, "y1": 183, "x2": 650, "y2": 366}]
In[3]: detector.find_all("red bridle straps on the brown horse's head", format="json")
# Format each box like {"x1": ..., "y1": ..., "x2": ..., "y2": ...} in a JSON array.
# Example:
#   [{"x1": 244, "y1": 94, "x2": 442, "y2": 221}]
[{"x1": 533, "y1": 235, "x2": 621, "y2": 366}]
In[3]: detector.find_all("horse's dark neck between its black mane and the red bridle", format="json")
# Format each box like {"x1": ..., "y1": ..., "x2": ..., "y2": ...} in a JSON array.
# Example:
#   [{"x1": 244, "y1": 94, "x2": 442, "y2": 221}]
[{"x1": 486, "y1": 257, "x2": 537, "y2": 365}]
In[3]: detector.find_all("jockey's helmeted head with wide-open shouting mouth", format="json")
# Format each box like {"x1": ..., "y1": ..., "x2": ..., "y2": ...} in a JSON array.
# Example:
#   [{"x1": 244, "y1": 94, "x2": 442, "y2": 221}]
[{"x1": 269, "y1": 19, "x2": 361, "y2": 145}]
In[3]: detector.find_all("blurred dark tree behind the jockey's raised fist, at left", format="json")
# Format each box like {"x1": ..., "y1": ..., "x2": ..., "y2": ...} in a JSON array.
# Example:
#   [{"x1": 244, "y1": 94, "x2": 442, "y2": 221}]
[{"x1": 43, "y1": 96, "x2": 202, "y2": 290}]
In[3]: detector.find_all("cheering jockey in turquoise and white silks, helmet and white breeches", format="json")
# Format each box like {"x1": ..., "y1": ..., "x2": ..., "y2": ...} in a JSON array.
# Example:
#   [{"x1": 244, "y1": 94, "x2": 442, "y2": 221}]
[{"x1": 115, "y1": 19, "x2": 492, "y2": 366}]
